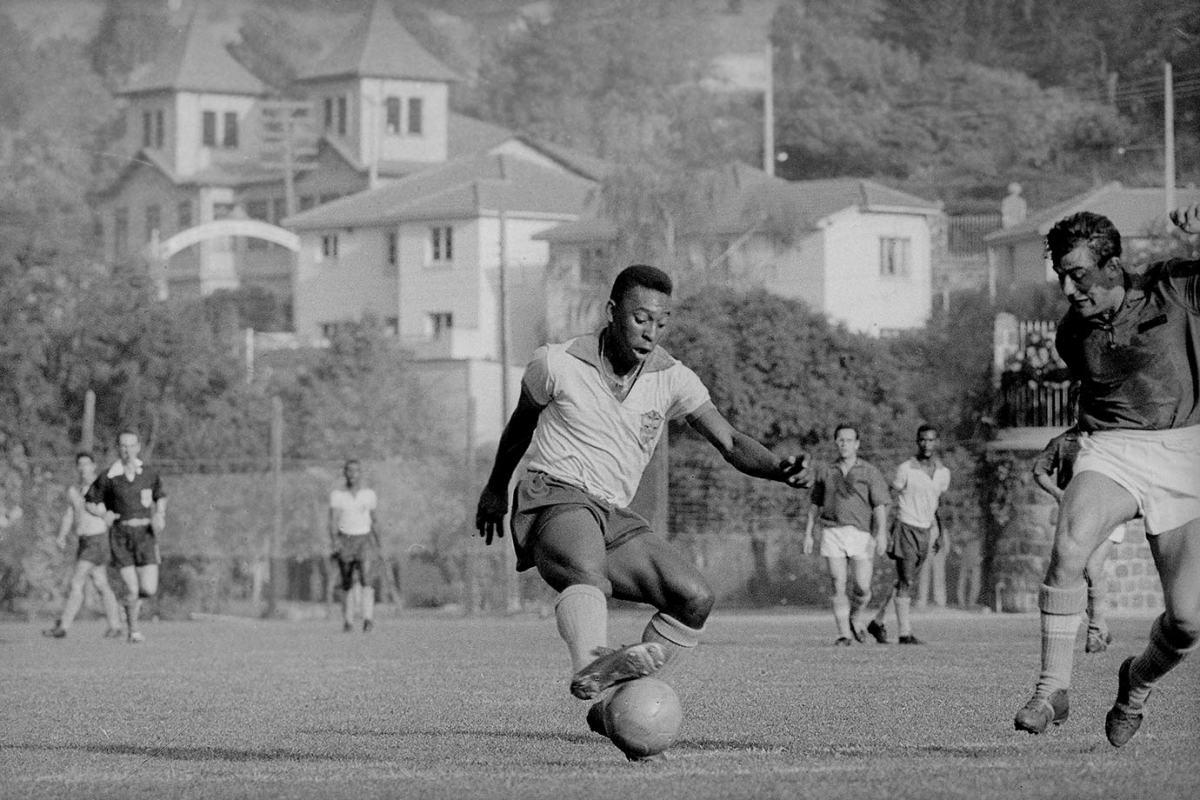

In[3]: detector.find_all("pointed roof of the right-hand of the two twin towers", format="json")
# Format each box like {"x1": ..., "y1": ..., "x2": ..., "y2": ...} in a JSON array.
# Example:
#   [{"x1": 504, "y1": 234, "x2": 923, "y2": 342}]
[{"x1": 296, "y1": 0, "x2": 460, "y2": 83}]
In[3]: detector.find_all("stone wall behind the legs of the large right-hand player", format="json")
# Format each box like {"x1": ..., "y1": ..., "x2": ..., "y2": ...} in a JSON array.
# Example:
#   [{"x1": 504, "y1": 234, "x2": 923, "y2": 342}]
[{"x1": 983, "y1": 441, "x2": 1163, "y2": 612}]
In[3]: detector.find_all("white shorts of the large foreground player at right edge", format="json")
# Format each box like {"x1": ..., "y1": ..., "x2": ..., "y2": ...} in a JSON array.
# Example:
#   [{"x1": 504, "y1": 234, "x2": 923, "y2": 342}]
[{"x1": 1075, "y1": 425, "x2": 1200, "y2": 536}]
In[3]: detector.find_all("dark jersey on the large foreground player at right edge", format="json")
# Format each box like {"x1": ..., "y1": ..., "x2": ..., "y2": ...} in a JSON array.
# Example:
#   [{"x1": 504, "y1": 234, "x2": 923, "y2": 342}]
[{"x1": 1056, "y1": 259, "x2": 1200, "y2": 431}]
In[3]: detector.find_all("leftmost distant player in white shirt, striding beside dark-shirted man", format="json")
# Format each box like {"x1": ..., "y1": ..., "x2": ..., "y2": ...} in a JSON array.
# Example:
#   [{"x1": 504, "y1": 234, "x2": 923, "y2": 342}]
[{"x1": 42, "y1": 452, "x2": 125, "y2": 639}]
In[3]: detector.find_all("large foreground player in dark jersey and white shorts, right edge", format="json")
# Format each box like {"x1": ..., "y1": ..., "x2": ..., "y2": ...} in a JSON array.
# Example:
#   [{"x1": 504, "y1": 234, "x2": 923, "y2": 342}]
[{"x1": 1013, "y1": 205, "x2": 1200, "y2": 747}]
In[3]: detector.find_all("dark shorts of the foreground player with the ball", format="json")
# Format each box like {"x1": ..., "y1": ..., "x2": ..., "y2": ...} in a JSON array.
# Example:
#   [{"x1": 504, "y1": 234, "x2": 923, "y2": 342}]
[{"x1": 511, "y1": 473, "x2": 650, "y2": 572}]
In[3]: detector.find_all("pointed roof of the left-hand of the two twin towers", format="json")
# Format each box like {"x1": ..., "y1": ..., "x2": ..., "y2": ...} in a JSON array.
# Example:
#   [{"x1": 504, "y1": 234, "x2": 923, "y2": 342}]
[{"x1": 116, "y1": 4, "x2": 269, "y2": 96}]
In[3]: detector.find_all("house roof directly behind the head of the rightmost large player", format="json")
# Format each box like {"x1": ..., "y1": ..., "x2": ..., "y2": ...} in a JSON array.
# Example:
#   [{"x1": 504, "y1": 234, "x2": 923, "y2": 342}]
[{"x1": 983, "y1": 181, "x2": 1200, "y2": 245}]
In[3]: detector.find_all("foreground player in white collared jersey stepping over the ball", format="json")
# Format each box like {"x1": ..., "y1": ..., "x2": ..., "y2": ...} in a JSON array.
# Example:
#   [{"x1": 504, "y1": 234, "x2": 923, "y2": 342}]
[{"x1": 475, "y1": 265, "x2": 808, "y2": 748}]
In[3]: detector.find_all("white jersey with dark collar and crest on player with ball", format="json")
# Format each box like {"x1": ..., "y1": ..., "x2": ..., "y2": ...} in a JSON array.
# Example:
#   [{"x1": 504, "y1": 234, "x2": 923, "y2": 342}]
[{"x1": 521, "y1": 333, "x2": 709, "y2": 507}]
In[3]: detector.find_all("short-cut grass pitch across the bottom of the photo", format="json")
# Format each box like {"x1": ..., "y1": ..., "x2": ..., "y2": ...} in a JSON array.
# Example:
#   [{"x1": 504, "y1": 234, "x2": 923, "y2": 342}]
[{"x1": 0, "y1": 612, "x2": 1200, "y2": 800}]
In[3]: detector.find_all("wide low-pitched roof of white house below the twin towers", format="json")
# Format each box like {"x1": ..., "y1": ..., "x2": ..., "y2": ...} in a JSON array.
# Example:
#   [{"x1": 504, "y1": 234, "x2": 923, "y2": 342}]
[{"x1": 282, "y1": 154, "x2": 594, "y2": 230}]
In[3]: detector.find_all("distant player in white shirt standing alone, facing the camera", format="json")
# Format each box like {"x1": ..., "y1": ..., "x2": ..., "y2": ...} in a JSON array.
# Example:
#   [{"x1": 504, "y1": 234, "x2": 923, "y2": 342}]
[{"x1": 329, "y1": 458, "x2": 380, "y2": 633}]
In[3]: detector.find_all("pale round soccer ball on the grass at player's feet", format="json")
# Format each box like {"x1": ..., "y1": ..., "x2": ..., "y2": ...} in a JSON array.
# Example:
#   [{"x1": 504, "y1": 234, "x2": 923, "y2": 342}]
[{"x1": 604, "y1": 678, "x2": 683, "y2": 759}]
